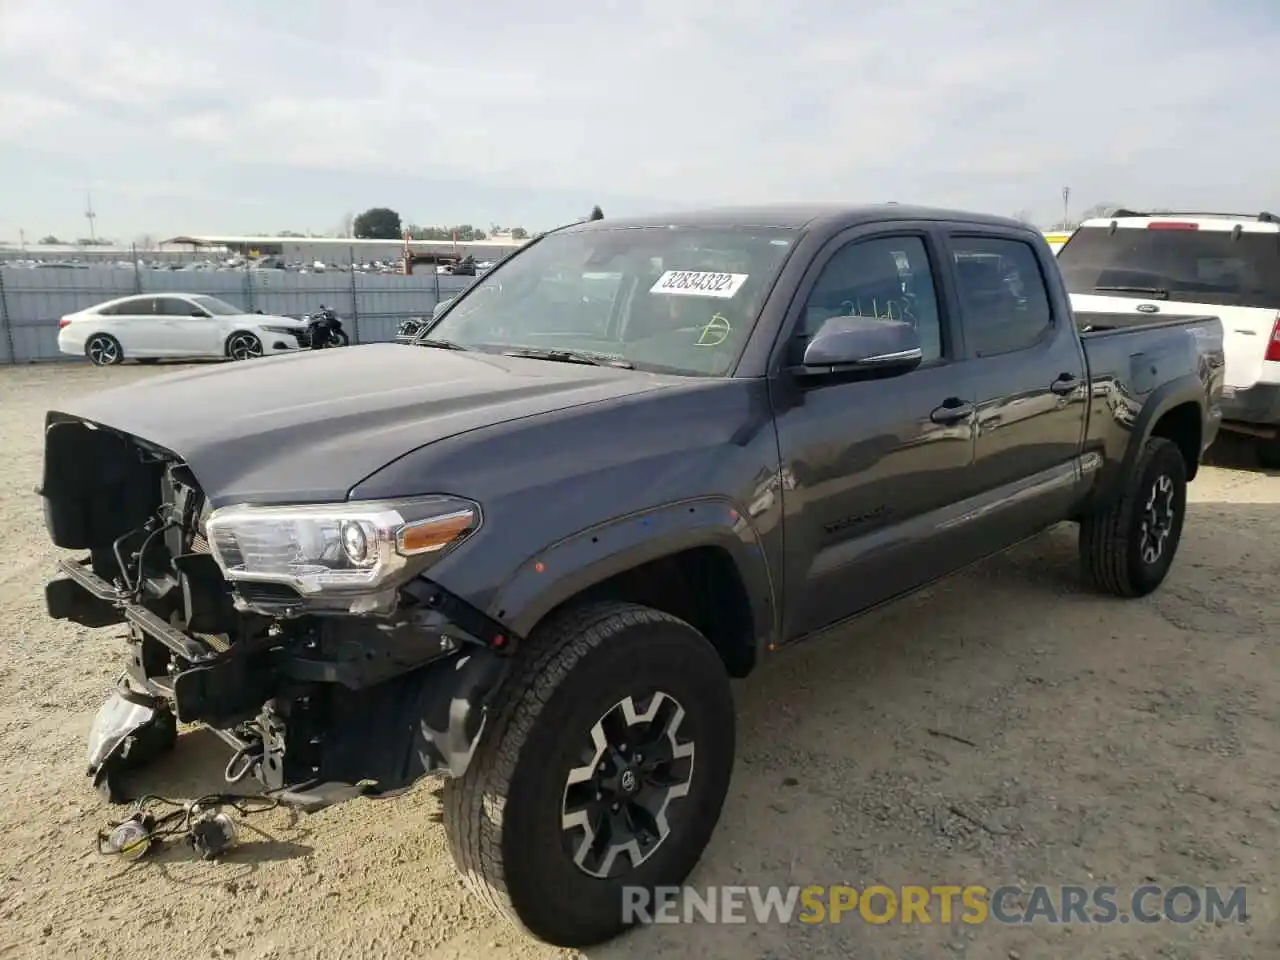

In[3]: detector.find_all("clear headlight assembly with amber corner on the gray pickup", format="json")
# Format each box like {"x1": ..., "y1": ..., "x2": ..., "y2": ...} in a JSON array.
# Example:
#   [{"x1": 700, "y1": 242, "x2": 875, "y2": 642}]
[{"x1": 205, "y1": 497, "x2": 481, "y2": 598}]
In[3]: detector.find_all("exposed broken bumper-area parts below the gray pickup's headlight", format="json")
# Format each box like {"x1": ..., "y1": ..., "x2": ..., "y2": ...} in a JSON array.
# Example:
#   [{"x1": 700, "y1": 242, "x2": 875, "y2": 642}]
[{"x1": 55, "y1": 562, "x2": 511, "y2": 809}]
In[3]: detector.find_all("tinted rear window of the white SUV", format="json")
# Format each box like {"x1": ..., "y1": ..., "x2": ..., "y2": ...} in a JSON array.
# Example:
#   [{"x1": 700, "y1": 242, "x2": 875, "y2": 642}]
[{"x1": 1057, "y1": 227, "x2": 1280, "y2": 310}]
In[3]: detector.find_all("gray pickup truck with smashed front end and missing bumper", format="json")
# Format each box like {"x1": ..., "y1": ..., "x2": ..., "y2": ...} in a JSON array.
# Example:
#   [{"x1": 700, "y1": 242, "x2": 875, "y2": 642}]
[{"x1": 40, "y1": 205, "x2": 1222, "y2": 946}]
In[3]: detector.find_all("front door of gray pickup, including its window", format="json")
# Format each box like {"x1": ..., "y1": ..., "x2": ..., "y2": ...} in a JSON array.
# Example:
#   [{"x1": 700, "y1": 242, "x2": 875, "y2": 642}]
[{"x1": 774, "y1": 227, "x2": 974, "y2": 640}]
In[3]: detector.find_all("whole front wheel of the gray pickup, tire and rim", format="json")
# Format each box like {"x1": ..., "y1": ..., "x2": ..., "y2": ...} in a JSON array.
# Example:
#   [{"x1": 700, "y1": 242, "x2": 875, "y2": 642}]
[{"x1": 444, "y1": 603, "x2": 735, "y2": 947}]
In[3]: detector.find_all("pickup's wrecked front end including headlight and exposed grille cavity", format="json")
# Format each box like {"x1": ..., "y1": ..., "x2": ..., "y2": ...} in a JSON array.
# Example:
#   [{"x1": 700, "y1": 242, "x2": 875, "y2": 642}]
[{"x1": 38, "y1": 413, "x2": 518, "y2": 809}]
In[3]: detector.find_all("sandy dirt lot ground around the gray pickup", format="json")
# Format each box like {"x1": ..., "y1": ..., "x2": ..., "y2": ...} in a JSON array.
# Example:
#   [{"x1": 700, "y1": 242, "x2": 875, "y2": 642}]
[{"x1": 0, "y1": 366, "x2": 1280, "y2": 960}]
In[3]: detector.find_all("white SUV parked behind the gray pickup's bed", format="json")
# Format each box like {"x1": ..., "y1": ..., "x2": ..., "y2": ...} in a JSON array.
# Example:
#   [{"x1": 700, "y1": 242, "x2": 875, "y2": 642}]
[{"x1": 1057, "y1": 210, "x2": 1280, "y2": 467}]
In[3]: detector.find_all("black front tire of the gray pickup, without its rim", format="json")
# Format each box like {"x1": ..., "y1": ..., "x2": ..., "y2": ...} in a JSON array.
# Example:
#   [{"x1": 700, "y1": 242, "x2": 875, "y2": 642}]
[{"x1": 443, "y1": 603, "x2": 735, "y2": 947}]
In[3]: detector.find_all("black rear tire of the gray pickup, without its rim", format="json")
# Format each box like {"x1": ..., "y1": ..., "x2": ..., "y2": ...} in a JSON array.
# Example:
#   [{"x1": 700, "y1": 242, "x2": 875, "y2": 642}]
[{"x1": 1080, "y1": 436, "x2": 1187, "y2": 596}]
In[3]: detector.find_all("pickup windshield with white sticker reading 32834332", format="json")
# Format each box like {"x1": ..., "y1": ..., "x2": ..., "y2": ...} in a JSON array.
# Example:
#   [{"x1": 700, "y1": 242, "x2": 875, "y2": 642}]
[{"x1": 422, "y1": 227, "x2": 796, "y2": 376}]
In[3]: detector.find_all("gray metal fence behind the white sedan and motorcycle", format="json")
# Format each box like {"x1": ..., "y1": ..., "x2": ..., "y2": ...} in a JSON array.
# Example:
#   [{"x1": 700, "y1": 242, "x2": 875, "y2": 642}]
[{"x1": 0, "y1": 253, "x2": 474, "y2": 364}]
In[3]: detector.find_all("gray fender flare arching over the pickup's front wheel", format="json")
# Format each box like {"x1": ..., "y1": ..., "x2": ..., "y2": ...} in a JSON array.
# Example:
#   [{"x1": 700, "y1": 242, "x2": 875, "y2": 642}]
[{"x1": 488, "y1": 497, "x2": 777, "y2": 653}]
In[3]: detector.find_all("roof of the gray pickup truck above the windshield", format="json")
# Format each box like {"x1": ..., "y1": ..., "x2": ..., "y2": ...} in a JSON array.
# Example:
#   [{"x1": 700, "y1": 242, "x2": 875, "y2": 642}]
[{"x1": 566, "y1": 204, "x2": 1028, "y2": 230}]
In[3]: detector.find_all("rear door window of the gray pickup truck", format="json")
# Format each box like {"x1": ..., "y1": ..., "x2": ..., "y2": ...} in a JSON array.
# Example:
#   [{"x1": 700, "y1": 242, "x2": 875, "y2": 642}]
[{"x1": 951, "y1": 237, "x2": 1053, "y2": 357}]
